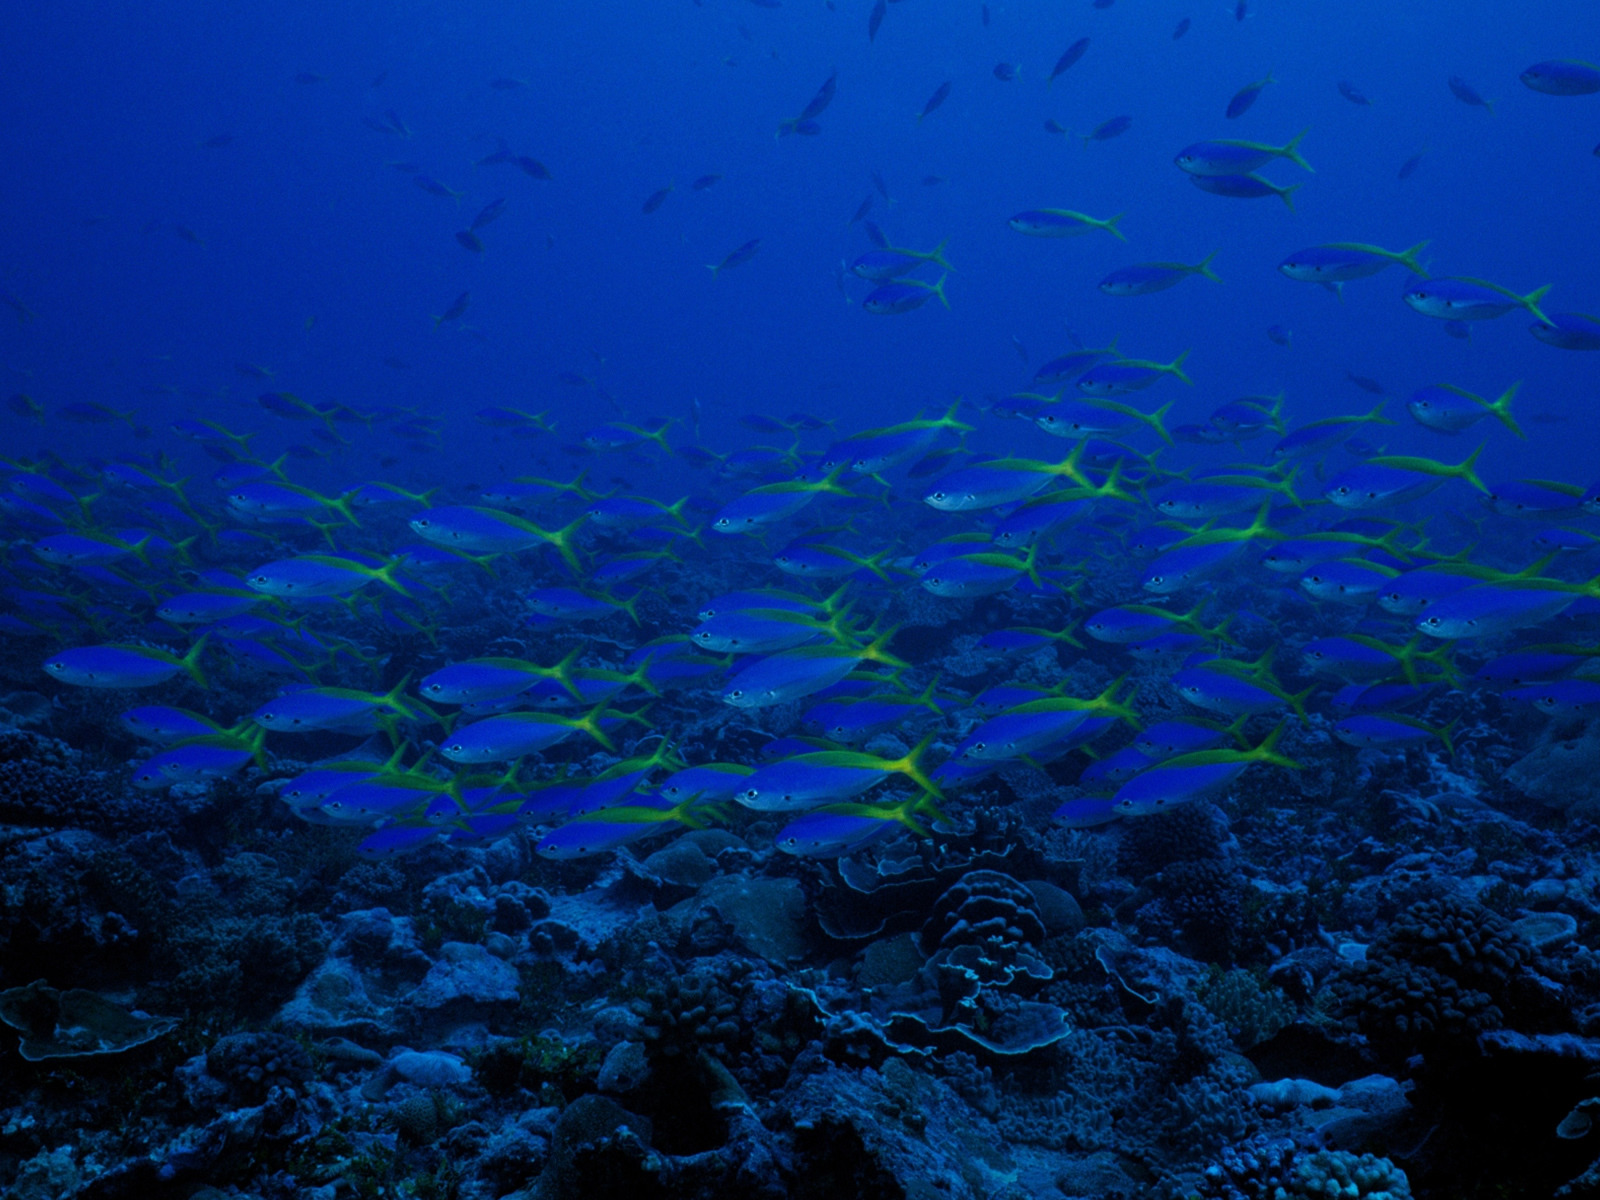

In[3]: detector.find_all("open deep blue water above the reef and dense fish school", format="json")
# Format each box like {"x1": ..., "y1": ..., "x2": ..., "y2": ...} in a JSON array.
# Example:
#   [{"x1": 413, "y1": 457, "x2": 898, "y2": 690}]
[{"x1": 0, "y1": 0, "x2": 1600, "y2": 483}]
